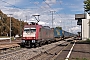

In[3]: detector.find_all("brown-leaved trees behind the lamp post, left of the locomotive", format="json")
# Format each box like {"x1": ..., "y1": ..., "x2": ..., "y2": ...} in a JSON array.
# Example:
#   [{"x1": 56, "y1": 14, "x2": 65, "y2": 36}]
[{"x1": 0, "y1": 10, "x2": 27, "y2": 36}]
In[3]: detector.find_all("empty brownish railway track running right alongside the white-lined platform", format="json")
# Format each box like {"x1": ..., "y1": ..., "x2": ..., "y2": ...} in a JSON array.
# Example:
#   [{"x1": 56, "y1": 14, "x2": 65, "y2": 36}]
[{"x1": 29, "y1": 41, "x2": 70, "y2": 60}]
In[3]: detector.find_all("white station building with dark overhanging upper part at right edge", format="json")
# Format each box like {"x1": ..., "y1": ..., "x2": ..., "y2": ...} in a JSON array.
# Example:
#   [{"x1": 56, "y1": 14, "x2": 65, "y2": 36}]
[{"x1": 75, "y1": 13, "x2": 90, "y2": 40}]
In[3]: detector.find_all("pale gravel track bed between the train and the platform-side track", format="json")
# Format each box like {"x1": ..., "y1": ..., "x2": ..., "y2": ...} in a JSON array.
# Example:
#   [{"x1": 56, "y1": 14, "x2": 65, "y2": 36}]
[{"x1": 0, "y1": 41, "x2": 64, "y2": 60}]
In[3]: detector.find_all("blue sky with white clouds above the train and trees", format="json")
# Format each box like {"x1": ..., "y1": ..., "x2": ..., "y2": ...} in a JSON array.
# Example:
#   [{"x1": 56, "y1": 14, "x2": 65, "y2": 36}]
[{"x1": 0, "y1": 0, "x2": 84, "y2": 33}]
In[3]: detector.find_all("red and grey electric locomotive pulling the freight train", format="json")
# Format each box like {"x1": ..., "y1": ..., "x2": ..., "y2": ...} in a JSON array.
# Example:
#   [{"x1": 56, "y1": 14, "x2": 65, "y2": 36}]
[{"x1": 21, "y1": 22, "x2": 54, "y2": 47}]
